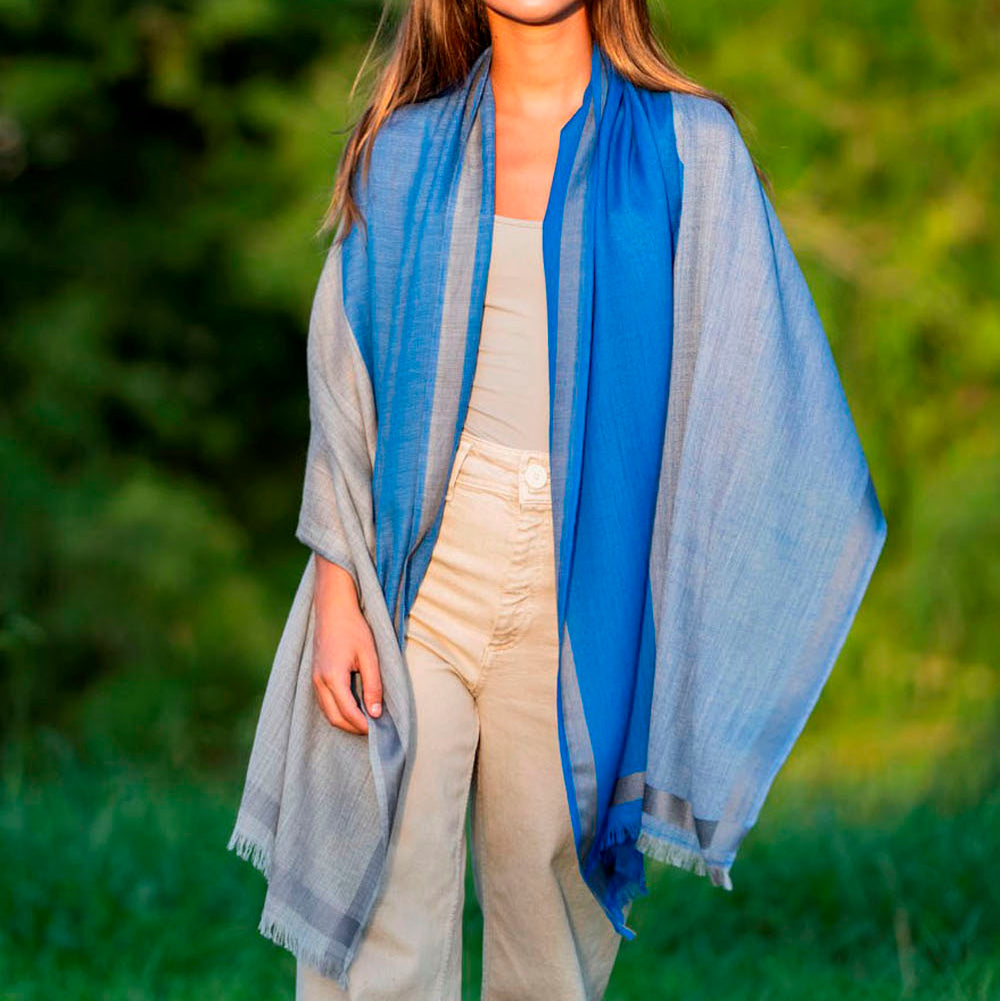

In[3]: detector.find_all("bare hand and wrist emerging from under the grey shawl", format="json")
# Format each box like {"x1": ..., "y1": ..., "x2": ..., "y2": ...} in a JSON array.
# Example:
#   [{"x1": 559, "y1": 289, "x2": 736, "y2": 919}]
[{"x1": 312, "y1": 553, "x2": 382, "y2": 734}]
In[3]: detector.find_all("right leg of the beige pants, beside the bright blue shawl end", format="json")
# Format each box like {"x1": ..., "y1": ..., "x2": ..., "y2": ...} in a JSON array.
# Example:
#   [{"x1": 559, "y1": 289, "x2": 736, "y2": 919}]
[{"x1": 471, "y1": 464, "x2": 622, "y2": 1001}]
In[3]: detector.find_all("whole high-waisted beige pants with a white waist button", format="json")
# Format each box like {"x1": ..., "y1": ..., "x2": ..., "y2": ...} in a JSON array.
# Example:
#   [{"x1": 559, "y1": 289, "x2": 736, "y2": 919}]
[{"x1": 295, "y1": 430, "x2": 622, "y2": 1001}]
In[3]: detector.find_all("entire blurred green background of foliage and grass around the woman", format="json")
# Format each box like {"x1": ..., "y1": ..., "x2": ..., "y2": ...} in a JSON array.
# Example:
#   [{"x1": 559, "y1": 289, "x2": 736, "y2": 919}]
[{"x1": 0, "y1": 0, "x2": 1000, "y2": 1001}]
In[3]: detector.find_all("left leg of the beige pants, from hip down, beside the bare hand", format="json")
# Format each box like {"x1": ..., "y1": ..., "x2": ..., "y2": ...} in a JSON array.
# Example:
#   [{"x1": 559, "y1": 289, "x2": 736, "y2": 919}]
[{"x1": 295, "y1": 439, "x2": 512, "y2": 1001}]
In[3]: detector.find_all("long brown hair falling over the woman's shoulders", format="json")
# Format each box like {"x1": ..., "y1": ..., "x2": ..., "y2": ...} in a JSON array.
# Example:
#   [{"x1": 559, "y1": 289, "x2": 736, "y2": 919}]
[{"x1": 318, "y1": 0, "x2": 770, "y2": 238}]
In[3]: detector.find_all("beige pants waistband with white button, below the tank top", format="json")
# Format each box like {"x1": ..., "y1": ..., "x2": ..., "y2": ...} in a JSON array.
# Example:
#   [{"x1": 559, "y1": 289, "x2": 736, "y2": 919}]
[{"x1": 446, "y1": 428, "x2": 552, "y2": 506}]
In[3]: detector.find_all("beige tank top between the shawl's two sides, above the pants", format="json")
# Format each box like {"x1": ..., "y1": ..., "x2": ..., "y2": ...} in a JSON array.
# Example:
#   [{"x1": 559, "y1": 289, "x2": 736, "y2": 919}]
[{"x1": 465, "y1": 215, "x2": 549, "y2": 450}]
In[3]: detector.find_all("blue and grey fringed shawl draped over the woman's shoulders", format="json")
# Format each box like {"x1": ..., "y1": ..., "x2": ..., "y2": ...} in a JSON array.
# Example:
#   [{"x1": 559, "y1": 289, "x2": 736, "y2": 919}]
[{"x1": 228, "y1": 43, "x2": 886, "y2": 986}]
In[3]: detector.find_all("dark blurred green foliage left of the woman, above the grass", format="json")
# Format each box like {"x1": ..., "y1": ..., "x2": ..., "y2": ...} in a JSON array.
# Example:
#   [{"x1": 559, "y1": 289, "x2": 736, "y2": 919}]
[{"x1": 0, "y1": 0, "x2": 386, "y2": 765}]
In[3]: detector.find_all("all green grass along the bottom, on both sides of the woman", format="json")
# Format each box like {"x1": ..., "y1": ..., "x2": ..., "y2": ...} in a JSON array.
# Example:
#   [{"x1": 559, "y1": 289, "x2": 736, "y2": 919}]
[{"x1": 0, "y1": 732, "x2": 1000, "y2": 1001}]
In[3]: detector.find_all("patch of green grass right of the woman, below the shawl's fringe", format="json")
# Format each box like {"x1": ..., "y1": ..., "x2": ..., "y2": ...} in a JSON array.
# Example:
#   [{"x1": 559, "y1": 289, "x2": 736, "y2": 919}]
[{"x1": 608, "y1": 795, "x2": 1000, "y2": 1001}]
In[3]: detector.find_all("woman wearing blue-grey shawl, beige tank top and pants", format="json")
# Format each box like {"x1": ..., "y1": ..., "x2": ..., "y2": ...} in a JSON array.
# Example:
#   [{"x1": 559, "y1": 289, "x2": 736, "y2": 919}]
[{"x1": 229, "y1": 0, "x2": 886, "y2": 1001}]
